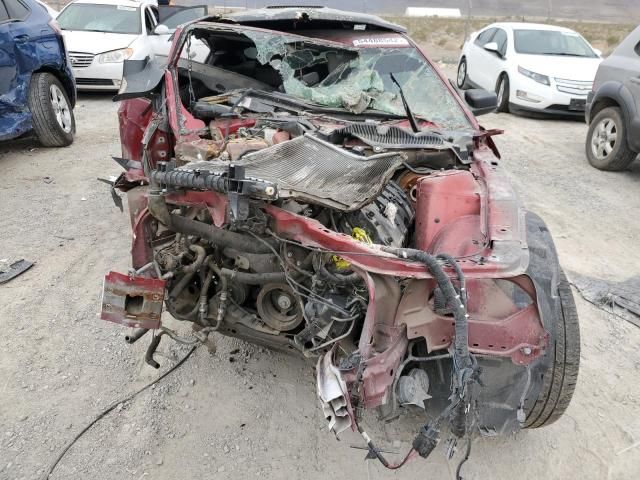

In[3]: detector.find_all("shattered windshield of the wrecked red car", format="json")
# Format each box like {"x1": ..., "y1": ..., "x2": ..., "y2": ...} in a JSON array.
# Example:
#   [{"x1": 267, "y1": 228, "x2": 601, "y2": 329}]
[{"x1": 192, "y1": 29, "x2": 471, "y2": 130}]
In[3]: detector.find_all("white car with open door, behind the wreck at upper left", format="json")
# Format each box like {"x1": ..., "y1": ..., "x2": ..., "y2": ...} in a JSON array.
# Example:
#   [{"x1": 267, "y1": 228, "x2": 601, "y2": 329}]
[{"x1": 57, "y1": 0, "x2": 208, "y2": 90}]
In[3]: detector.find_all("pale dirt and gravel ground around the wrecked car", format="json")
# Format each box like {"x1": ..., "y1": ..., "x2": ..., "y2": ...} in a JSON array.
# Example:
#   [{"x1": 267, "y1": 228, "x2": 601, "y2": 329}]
[{"x1": 0, "y1": 73, "x2": 640, "y2": 480}]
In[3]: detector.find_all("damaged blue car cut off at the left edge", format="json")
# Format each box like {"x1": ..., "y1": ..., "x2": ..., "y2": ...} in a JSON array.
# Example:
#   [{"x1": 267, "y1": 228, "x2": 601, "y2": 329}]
[{"x1": 0, "y1": 0, "x2": 76, "y2": 147}]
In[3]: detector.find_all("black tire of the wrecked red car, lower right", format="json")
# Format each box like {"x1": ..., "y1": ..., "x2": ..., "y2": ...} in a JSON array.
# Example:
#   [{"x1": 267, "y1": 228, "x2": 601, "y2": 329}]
[{"x1": 525, "y1": 270, "x2": 580, "y2": 428}]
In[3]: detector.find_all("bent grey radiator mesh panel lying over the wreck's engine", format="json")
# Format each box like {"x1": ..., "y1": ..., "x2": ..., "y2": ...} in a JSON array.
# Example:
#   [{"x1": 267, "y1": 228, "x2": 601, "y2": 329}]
[{"x1": 180, "y1": 135, "x2": 405, "y2": 211}]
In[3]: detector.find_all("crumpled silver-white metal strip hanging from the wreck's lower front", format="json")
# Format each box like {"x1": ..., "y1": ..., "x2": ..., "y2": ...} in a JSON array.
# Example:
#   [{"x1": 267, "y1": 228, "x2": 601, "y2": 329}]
[{"x1": 316, "y1": 352, "x2": 351, "y2": 435}]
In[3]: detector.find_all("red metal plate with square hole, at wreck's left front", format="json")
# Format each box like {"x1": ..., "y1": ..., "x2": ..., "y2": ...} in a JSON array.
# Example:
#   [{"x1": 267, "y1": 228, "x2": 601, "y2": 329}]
[{"x1": 100, "y1": 272, "x2": 166, "y2": 329}]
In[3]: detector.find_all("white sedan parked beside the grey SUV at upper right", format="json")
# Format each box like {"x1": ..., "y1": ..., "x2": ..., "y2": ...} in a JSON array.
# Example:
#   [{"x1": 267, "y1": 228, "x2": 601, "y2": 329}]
[{"x1": 457, "y1": 23, "x2": 602, "y2": 117}]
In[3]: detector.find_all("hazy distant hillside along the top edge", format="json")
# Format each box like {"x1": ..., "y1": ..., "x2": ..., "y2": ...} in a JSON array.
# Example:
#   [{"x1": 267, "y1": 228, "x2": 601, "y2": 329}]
[{"x1": 204, "y1": 0, "x2": 640, "y2": 23}]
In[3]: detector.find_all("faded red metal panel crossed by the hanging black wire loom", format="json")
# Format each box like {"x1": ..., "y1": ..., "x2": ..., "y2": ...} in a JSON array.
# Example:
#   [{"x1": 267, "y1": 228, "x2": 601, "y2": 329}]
[{"x1": 396, "y1": 280, "x2": 549, "y2": 365}]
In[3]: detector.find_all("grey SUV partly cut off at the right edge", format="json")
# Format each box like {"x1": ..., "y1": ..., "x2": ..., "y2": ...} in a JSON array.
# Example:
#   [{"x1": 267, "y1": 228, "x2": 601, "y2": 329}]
[{"x1": 586, "y1": 27, "x2": 640, "y2": 170}]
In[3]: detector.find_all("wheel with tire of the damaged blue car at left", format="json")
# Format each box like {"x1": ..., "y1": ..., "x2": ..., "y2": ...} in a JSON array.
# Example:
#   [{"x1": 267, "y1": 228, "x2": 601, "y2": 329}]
[{"x1": 28, "y1": 72, "x2": 76, "y2": 147}]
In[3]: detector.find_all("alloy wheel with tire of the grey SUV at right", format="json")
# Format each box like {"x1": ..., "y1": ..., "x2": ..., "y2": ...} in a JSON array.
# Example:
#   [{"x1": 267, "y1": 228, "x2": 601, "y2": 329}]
[{"x1": 586, "y1": 107, "x2": 637, "y2": 171}]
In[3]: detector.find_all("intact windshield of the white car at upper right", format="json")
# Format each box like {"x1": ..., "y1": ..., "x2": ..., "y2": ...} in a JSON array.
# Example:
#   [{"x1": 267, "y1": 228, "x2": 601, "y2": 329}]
[{"x1": 514, "y1": 30, "x2": 597, "y2": 58}]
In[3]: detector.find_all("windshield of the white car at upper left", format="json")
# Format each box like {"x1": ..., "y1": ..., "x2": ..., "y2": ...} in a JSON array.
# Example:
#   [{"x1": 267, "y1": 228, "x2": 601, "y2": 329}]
[{"x1": 57, "y1": 3, "x2": 142, "y2": 35}]
